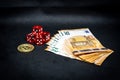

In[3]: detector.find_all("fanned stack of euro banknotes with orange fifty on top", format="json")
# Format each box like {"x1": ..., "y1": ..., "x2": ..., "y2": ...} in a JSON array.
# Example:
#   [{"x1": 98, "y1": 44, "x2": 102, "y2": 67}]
[{"x1": 45, "y1": 28, "x2": 113, "y2": 66}]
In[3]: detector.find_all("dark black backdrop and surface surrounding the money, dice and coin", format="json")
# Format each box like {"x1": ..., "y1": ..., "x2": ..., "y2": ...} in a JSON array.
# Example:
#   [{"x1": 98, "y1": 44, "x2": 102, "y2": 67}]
[{"x1": 0, "y1": 0, "x2": 120, "y2": 80}]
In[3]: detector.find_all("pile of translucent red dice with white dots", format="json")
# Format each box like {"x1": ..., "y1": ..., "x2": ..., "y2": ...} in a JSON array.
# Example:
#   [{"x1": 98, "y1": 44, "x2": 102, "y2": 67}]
[{"x1": 26, "y1": 25, "x2": 50, "y2": 45}]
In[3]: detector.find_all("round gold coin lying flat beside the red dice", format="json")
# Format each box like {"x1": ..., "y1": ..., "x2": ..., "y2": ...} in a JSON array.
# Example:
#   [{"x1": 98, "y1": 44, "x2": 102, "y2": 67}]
[{"x1": 17, "y1": 43, "x2": 34, "y2": 53}]
